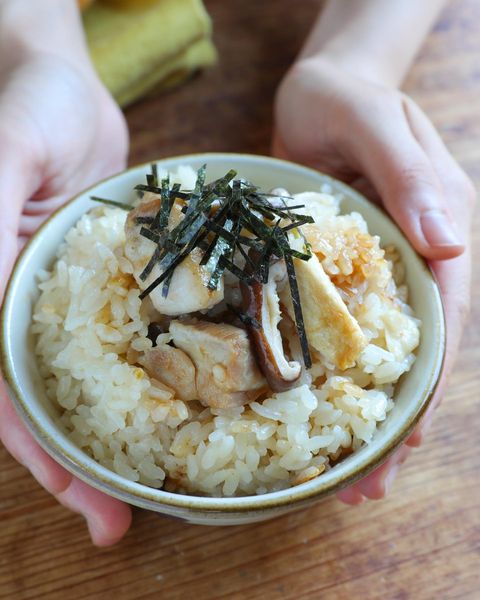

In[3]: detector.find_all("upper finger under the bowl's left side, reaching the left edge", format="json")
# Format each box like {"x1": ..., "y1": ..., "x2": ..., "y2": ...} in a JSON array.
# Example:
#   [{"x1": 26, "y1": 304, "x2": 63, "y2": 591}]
[{"x1": 0, "y1": 379, "x2": 72, "y2": 494}]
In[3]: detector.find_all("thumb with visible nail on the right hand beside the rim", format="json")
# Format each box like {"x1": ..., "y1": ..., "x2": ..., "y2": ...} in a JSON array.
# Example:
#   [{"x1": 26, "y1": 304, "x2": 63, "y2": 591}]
[{"x1": 344, "y1": 96, "x2": 465, "y2": 260}]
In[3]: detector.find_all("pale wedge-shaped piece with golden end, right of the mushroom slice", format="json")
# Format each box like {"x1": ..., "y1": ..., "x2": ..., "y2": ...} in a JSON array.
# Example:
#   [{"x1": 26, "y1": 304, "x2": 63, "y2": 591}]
[{"x1": 281, "y1": 255, "x2": 367, "y2": 369}]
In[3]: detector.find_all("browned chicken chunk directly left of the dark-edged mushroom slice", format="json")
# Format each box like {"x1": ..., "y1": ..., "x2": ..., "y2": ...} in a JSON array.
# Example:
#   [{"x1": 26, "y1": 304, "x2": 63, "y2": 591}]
[{"x1": 170, "y1": 320, "x2": 266, "y2": 408}]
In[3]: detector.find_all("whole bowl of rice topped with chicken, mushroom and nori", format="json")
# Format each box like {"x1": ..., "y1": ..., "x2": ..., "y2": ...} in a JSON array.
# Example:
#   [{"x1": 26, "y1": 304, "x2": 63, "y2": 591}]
[{"x1": 1, "y1": 154, "x2": 445, "y2": 524}]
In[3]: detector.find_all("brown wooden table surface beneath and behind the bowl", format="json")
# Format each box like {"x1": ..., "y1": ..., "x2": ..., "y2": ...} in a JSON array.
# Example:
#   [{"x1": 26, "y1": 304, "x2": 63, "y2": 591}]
[{"x1": 0, "y1": 0, "x2": 480, "y2": 600}]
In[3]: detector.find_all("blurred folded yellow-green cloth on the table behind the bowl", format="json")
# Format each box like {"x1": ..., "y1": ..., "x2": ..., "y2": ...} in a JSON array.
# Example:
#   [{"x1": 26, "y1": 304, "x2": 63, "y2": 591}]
[{"x1": 79, "y1": 0, "x2": 217, "y2": 107}]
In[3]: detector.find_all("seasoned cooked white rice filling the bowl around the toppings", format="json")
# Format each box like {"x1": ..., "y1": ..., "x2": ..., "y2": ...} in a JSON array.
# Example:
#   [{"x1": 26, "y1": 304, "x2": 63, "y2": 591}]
[{"x1": 32, "y1": 169, "x2": 419, "y2": 496}]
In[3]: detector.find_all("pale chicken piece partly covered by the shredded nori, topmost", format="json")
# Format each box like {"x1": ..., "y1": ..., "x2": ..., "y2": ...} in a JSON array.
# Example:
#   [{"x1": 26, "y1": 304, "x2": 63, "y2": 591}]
[{"x1": 125, "y1": 194, "x2": 223, "y2": 316}]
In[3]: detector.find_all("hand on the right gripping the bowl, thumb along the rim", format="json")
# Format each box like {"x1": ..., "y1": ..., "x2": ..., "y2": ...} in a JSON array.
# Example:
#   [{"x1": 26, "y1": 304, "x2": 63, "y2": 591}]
[{"x1": 272, "y1": 56, "x2": 475, "y2": 504}]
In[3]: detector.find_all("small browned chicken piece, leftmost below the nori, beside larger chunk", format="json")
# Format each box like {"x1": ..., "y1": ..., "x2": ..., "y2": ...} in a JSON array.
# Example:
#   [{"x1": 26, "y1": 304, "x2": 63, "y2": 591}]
[{"x1": 141, "y1": 344, "x2": 198, "y2": 401}]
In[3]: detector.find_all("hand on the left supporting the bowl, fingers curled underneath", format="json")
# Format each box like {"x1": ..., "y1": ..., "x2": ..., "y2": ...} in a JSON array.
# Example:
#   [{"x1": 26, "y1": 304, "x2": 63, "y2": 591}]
[{"x1": 0, "y1": 41, "x2": 131, "y2": 546}]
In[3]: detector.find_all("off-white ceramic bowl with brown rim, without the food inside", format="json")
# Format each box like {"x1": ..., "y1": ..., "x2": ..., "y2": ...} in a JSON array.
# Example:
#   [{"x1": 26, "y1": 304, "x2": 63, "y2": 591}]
[{"x1": 0, "y1": 154, "x2": 445, "y2": 525}]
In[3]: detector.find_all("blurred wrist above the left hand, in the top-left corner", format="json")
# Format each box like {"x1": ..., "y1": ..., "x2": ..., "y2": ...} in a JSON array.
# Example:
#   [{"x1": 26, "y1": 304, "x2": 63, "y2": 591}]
[{"x1": 0, "y1": 0, "x2": 93, "y2": 73}]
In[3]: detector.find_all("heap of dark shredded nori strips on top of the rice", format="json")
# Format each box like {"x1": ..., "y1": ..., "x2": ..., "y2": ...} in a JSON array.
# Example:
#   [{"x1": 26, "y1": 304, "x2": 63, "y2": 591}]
[{"x1": 105, "y1": 163, "x2": 314, "y2": 368}]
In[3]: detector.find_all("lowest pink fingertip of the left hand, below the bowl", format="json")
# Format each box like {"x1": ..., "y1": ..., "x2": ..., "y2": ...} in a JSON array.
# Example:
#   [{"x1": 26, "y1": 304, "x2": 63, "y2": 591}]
[{"x1": 57, "y1": 477, "x2": 132, "y2": 546}]
